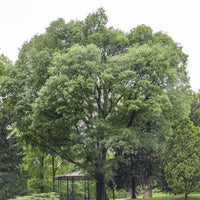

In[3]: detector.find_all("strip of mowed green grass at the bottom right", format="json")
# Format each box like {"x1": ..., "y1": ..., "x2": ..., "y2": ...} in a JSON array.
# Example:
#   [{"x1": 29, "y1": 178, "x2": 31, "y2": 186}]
[{"x1": 135, "y1": 193, "x2": 200, "y2": 200}]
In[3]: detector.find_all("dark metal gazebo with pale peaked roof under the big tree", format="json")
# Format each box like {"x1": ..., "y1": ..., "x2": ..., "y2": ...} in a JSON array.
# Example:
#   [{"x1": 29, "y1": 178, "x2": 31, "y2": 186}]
[{"x1": 54, "y1": 171, "x2": 90, "y2": 200}]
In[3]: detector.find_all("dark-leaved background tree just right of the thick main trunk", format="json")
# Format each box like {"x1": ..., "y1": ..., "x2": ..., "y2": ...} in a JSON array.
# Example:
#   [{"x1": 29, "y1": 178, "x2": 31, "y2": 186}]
[{"x1": 113, "y1": 130, "x2": 169, "y2": 199}]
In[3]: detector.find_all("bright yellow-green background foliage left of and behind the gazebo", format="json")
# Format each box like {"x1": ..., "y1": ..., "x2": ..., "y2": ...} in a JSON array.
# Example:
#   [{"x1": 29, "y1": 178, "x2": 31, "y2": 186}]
[{"x1": 23, "y1": 144, "x2": 74, "y2": 194}]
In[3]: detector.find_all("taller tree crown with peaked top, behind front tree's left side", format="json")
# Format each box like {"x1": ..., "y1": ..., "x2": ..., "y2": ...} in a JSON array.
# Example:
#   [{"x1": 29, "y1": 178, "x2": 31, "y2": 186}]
[{"x1": 2, "y1": 9, "x2": 127, "y2": 198}]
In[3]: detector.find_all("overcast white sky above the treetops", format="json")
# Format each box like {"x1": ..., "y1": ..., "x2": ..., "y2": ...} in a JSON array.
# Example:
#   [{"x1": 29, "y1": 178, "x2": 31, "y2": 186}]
[{"x1": 0, "y1": 0, "x2": 200, "y2": 91}]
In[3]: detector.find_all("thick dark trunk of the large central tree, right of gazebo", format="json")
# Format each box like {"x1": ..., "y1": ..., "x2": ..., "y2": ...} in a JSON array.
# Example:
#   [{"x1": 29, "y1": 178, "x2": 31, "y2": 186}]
[{"x1": 95, "y1": 173, "x2": 106, "y2": 200}]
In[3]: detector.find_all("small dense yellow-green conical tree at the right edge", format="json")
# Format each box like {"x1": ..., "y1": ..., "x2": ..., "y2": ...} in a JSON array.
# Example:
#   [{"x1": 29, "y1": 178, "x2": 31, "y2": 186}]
[{"x1": 165, "y1": 118, "x2": 200, "y2": 199}]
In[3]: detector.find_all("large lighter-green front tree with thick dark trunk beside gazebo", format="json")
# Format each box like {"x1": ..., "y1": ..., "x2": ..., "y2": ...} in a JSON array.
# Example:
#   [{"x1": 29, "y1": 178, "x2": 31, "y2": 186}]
[{"x1": 31, "y1": 41, "x2": 189, "y2": 199}]
